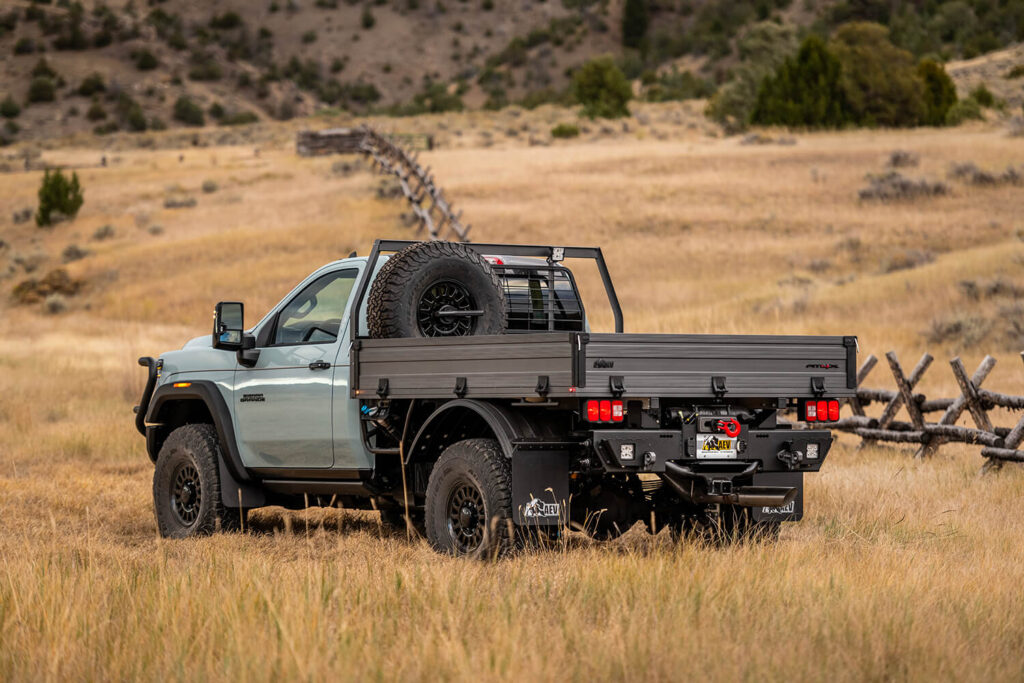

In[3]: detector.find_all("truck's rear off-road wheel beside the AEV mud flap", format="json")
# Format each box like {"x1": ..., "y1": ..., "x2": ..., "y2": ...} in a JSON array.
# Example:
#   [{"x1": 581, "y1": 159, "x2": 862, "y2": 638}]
[{"x1": 426, "y1": 438, "x2": 512, "y2": 559}]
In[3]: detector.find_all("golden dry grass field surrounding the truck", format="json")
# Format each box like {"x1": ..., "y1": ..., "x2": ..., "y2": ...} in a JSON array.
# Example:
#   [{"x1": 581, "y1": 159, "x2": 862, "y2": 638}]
[{"x1": 0, "y1": 109, "x2": 1024, "y2": 681}]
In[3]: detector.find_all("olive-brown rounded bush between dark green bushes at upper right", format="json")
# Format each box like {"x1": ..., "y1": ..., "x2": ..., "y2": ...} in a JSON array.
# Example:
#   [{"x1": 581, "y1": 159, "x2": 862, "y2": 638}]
[{"x1": 829, "y1": 22, "x2": 928, "y2": 127}]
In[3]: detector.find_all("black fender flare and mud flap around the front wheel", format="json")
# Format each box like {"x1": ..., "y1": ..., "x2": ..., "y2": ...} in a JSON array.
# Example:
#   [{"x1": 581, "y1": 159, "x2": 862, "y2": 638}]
[{"x1": 145, "y1": 380, "x2": 266, "y2": 507}]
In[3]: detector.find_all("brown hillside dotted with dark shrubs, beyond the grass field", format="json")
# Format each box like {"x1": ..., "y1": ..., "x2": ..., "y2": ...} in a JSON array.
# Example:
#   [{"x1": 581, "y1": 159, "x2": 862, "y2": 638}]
[{"x1": 0, "y1": 0, "x2": 1024, "y2": 142}]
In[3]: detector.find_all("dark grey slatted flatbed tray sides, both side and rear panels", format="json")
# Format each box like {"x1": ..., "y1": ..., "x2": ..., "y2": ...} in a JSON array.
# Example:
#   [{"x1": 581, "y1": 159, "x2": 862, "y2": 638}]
[{"x1": 350, "y1": 332, "x2": 856, "y2": 399}]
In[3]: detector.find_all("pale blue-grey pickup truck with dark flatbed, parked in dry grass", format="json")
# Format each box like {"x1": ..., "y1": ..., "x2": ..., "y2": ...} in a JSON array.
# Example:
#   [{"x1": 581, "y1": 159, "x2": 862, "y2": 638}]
[{"x1": 135, "y1": 241, "x2": 857, "y2": 556}]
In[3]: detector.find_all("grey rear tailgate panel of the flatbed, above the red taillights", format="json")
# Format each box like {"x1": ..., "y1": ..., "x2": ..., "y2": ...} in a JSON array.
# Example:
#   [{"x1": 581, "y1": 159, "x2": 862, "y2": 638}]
[{"x1": 580, "y1": 334, "x2": 856, "y2": 398}]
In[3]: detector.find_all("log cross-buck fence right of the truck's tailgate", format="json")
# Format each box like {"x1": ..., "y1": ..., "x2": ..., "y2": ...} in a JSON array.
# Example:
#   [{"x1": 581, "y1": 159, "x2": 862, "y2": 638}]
[{"x1": 835, "y1": 351, "x2": 1024, "y2": 471}]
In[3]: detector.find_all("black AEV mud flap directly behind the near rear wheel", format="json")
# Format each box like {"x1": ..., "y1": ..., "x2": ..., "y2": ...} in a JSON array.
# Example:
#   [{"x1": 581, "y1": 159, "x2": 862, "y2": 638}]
[{"x1": 512, "y1": 451, "x2": 569, "y2": 526}]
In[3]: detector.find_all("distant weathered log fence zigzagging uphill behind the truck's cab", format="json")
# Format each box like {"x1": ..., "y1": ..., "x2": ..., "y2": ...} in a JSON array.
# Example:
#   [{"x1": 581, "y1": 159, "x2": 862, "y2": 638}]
[{"x1": 295, "y1": 126, "x2": 470, "y2": 242}]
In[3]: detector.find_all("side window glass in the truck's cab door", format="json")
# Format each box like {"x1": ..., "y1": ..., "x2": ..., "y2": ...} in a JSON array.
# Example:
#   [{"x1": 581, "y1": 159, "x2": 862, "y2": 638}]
[{"x1": 270, "y1": 268, "x2": 358, "y2": 345}]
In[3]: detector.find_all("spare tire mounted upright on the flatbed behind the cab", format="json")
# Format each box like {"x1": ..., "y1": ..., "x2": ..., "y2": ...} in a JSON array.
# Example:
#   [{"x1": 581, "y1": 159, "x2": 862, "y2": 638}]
[{"x1": 367, "y1": 242, "x2": 507, "y2": 339}]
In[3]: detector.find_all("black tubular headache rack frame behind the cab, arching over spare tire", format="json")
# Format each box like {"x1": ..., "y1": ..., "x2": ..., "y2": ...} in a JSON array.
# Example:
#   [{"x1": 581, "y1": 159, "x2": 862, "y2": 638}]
[{"x1": 348, "y1": 240, "x2": 623, "y2": 348}]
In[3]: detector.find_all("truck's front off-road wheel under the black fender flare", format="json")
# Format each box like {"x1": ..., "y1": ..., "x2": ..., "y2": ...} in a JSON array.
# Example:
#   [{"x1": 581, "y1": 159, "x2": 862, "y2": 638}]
[{"x1": 153, "y1": 424, "x2": 237, "y2": 539}]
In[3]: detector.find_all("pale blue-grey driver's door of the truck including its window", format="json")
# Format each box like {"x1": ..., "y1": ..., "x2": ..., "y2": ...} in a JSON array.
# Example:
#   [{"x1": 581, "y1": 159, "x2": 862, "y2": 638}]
[{"x1": 234, "y1": 267, "x2": 358, "y2": 469}]
